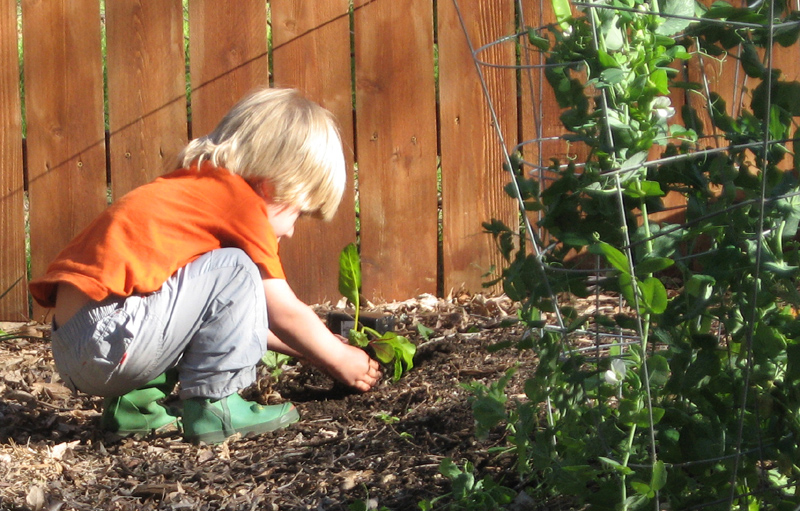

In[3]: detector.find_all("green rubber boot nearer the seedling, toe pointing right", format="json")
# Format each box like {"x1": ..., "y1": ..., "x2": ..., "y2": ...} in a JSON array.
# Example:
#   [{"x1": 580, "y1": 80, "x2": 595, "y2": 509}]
[{"x1": 183, "y1": 394, "x2": 300, "y2": 444}]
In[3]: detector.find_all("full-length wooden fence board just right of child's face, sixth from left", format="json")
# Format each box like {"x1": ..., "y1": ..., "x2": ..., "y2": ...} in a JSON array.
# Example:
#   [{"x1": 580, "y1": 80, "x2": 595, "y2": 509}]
[{"x1": 354, "y1": 0, "x2": 438, "y2": 299}]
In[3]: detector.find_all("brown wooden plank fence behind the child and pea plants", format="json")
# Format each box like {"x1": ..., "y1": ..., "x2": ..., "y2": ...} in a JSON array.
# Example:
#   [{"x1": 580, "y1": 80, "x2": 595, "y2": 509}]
[{"x1": 0, "y1": 0, "x2": 800, "y2": 320}]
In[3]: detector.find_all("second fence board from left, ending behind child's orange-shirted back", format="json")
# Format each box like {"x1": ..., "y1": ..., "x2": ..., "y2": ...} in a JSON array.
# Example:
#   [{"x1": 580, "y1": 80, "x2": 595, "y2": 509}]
[{"x1": 22, "y1": 0, "x2": 106, "y2": 319}]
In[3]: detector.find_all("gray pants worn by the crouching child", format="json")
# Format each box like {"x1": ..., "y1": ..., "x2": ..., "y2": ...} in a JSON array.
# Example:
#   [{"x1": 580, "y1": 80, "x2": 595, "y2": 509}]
[{"x1": 52, "y1": 248, "x2": 268, "y2": 399}]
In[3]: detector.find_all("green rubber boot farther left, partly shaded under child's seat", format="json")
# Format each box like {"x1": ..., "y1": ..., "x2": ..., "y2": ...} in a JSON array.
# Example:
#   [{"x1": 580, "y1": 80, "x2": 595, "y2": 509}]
[{"x1": 100, "y1": 370, "x2": 180, "y2": 436}]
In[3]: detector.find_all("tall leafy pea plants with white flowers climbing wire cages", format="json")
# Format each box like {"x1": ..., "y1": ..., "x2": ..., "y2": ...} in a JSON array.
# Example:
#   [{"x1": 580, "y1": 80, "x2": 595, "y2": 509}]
[{"x1": 482, "y1": 0, "x2": 800, "y2": 510}]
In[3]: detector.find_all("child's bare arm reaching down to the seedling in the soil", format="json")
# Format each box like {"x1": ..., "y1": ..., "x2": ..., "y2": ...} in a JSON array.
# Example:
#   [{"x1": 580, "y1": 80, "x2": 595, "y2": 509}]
[{"x1": 264, "y1": 279, "x2": 381, "y2": 391}]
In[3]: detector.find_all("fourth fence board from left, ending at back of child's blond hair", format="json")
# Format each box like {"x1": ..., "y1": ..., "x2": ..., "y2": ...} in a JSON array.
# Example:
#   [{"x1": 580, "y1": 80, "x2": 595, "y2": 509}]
[{"x1": 189, "y1": 0, "x2": 269, "y2": 138}]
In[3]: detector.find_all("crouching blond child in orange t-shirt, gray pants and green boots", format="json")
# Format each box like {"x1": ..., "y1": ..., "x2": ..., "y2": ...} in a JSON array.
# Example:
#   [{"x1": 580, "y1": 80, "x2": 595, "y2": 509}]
[{"x1": 30, "y1": 89, "x2": 381, "y2": 443}]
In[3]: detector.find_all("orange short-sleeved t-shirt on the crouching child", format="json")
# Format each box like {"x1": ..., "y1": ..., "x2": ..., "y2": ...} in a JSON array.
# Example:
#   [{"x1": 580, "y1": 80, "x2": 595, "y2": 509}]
[{"x1": 30, "y1": 163, "x2": 285, "y2": 307}]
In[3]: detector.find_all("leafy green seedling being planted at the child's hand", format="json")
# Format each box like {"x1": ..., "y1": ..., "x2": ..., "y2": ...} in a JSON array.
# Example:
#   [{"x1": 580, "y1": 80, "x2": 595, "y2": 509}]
[{"x1": 339, "y1": 243, "x2": 417, "y2": 381}]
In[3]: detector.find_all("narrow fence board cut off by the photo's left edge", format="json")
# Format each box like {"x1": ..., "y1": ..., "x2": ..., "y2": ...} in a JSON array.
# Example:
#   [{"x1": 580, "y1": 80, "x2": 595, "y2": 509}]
[{"x1": 0, "y1": 0, "x2": 28, "y2": 321}]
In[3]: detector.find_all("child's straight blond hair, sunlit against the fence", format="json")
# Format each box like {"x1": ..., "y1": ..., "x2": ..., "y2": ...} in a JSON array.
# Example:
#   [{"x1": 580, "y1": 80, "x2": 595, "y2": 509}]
[{"x1": 178, "y1": 89, "x2": 346, "y2": 220}]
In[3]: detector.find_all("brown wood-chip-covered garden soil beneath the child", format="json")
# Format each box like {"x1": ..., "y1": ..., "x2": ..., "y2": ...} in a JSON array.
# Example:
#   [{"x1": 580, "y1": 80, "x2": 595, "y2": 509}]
[{"x1": 0, "y1": 295, "x2": 552, "y2": 511}]
